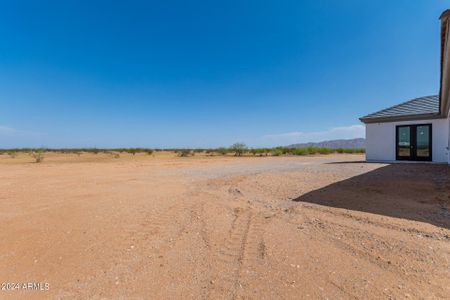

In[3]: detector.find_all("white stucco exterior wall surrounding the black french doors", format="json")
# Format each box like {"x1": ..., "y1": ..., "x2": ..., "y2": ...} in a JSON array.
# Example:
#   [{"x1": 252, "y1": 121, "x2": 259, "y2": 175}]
[{"x1": 366, "y1": 118, "x2": 450, "y2": 163}]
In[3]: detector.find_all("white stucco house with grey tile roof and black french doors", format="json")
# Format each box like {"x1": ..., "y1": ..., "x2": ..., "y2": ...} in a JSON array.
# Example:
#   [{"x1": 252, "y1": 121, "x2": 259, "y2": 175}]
[{"x1": 360, "y1": 10, "x2": 450, "y2": 164}]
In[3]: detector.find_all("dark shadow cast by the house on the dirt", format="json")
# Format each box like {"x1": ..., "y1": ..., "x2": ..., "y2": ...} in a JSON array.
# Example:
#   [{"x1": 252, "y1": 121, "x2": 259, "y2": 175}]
[{"x1": 293, "y1": 162, "x2": 450, "y2": 229}]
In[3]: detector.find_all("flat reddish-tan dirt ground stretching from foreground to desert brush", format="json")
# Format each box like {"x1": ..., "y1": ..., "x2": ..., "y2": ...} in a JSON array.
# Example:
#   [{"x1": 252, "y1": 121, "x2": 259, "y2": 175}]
[{"x1": 0, "y1": 154, "x2": 450, "y2": 299}]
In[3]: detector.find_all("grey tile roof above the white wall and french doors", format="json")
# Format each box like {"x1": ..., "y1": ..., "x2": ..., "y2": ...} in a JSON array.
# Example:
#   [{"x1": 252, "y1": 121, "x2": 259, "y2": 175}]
[{"x1": 360, "y1": 95, "x2": 439, "y2": 122}]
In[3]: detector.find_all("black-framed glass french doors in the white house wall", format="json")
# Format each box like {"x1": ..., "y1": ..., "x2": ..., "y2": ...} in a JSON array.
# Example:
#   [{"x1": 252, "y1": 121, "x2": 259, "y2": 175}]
[{"x1": 396, "y1": 124, "x2": 432, "y2": 161}]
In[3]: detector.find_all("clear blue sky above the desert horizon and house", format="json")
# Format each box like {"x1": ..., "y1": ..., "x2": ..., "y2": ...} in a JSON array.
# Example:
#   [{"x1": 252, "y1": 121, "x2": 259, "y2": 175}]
[{"x1": 0, "y1": 0, "x2": 450, "y2": 148}]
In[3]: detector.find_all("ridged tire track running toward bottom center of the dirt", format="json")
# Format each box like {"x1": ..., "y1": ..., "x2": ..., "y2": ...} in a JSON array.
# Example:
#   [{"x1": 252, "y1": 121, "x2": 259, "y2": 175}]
[{"x1": 207, "y1": 208, "x2": 265, "y2": 299}]
